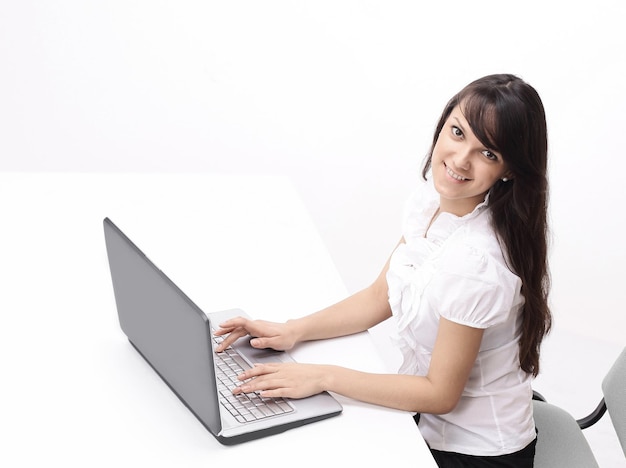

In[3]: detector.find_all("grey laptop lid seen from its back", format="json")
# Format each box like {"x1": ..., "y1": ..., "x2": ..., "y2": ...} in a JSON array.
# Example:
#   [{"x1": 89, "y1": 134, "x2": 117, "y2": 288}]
[{"x1": 104, "y1": 218, "x2": 221, "y2": 436}]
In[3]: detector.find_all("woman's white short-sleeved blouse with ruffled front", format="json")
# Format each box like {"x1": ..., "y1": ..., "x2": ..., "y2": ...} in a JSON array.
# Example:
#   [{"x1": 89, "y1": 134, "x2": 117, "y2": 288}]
[{"x1": 387, "y1": 181, "x2": 536, "y2": 456}]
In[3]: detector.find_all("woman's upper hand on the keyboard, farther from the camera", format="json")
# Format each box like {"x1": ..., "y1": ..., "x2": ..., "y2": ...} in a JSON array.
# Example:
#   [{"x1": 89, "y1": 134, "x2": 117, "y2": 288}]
[{"x1": 215, "y1": 317, "x2": 298, "y2": 353}]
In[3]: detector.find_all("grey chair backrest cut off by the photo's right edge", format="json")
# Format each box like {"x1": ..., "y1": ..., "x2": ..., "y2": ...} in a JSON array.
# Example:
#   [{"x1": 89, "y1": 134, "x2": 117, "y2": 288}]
[{"x1": 602, "y1": 348, "x2": 626, "y2": 456}]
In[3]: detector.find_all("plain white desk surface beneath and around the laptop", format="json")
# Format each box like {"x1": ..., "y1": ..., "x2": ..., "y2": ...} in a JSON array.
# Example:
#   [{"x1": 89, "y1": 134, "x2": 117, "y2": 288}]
[{"x1": 0, "y1": 174, "x2": 435, "y2": 467}]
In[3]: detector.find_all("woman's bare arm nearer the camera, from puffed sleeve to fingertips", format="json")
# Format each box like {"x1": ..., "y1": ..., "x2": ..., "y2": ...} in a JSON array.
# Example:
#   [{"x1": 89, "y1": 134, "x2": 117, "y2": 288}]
[{"x1": 236, "y1": 318, "x2": 483, "y2": 414}]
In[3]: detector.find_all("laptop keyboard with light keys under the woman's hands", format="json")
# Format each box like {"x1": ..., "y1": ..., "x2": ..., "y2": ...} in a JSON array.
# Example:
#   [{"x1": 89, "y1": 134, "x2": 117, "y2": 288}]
[{"x1": 213, "y1": 335, "x2": 293, "y2": 423}]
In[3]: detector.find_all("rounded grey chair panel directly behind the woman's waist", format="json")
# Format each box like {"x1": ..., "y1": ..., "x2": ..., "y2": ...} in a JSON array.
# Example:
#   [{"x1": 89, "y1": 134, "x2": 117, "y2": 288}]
[{"x1": 533, "y1": 400, "x2": 599, "y2": 468}]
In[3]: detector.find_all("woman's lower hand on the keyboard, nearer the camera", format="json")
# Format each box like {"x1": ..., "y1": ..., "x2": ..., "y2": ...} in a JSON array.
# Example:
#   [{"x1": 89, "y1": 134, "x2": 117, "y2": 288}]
[{"x1": 233, "y1": 363, "x2": 329, "y2": 398}]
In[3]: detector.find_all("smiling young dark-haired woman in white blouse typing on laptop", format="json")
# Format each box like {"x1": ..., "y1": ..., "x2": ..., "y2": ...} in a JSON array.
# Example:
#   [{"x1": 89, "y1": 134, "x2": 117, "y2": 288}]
[{"x1": 217, "y1": 75, "x2": 551, "y2": 467}]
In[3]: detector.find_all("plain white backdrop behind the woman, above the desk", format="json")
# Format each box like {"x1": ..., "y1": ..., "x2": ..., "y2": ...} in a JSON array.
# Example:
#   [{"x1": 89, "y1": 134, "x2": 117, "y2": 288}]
[{"x1": 0, "y1": 0, "x2": 626, "y2": 466}]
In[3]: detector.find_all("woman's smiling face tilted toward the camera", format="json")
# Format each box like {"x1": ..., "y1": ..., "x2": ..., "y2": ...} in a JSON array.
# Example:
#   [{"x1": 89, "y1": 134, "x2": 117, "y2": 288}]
[{"x1": 432, "y1": 106, "x2": 510, "y2": 216}]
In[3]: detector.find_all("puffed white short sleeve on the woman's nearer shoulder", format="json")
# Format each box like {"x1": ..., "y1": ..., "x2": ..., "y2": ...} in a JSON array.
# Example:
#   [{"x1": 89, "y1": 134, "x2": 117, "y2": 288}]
[{"x1": 424, "y1": 238, "x2": 523, "y2": 329}]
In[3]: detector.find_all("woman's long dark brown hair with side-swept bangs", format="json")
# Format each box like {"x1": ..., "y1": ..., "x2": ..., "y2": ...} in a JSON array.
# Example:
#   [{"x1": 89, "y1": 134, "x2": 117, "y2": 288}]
[{"x1": 422, "y1": 74, "x2": 552, "y2": 376}]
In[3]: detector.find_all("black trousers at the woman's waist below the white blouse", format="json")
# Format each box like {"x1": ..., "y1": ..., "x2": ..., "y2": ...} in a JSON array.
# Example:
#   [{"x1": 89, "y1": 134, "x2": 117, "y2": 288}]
[{"x1": 413, "y1": 414, "x2": 537, "y2": 468}]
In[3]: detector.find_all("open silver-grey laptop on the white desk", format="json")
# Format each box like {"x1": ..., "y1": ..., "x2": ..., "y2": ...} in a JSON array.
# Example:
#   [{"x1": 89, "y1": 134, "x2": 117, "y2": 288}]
[{"x1": 103, "y1": 218, "x2": 342, "y2": 445}]
